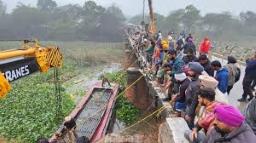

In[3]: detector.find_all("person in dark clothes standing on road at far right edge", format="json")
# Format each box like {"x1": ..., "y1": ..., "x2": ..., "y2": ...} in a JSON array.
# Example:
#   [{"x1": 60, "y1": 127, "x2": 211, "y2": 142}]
[{"x1": 238, "y1": 53, "x2": 256, "y2": 102}]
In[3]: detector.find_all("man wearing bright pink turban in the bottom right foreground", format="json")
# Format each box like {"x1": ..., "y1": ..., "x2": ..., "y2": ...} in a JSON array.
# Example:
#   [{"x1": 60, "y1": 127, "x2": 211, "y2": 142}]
[{"x1": 204, "y1": 105, "x2": 256, "y2": 143}]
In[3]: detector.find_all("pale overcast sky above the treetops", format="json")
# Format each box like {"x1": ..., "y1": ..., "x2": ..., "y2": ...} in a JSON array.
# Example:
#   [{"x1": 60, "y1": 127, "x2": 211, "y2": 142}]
[{"x1": 2, "y1": 0, "x2": 256, "y2": 16}]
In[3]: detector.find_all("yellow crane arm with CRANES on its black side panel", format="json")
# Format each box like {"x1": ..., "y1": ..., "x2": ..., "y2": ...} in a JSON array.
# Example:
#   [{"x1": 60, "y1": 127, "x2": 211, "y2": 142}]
[{"x1": 0, "y1": 40, "x2": 62, "y2": 98}]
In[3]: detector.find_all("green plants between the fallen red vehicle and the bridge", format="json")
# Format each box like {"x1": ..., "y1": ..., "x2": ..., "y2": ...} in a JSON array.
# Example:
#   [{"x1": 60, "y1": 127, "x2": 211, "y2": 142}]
[{"x1": 106, "y1": 71, "x2": 140, "y2": 125}]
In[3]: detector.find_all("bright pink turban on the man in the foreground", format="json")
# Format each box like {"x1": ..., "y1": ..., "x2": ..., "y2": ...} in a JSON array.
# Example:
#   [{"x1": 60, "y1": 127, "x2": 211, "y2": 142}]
[{"x1": 214, "y1": 105, "x2": 245, "y2": 127}]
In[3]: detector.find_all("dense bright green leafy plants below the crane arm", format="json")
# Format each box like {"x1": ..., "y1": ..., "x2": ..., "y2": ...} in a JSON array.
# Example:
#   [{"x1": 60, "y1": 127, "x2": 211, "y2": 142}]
[{"x1": 0, "y1": 74, "x2": 74, "y2": 143}]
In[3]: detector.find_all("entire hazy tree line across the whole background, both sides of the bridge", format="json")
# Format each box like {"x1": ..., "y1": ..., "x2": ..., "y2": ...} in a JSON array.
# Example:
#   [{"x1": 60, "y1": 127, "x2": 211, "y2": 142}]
[{"x1": 0, "y1": 0, "x2": 256, "y2": 41}]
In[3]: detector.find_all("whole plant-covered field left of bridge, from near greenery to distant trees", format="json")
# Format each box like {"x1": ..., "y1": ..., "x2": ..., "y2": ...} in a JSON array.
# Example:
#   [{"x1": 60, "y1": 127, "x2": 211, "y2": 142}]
[{"x1": 0, "y1": 41, "x2": 124, "y2": 143}]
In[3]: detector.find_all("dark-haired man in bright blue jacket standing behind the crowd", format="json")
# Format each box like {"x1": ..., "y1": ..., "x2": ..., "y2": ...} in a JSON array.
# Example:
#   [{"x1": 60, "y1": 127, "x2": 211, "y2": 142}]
[{"x1": 211, "y1": 60, "x2": 228, "y2": 93}]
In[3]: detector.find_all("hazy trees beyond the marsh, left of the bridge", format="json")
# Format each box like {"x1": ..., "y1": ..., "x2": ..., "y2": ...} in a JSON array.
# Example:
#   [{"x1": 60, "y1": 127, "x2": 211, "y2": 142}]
[{"x1": 0, "y1": 0, "x2": 125, "y2": 41}]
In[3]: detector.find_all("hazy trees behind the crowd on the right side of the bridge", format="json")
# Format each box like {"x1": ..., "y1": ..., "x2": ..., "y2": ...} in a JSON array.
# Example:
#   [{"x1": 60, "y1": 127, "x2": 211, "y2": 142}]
[{"x1": 129, "y1": 5, "x2": 256, "y2": 41}]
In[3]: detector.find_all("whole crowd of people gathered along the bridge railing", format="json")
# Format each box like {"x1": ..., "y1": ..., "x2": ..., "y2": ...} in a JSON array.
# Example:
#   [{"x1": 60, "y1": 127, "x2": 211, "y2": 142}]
[{"x1": 133, "y1": 28, "x2": 256, "y2": 143}]
